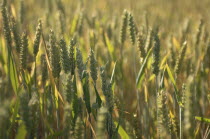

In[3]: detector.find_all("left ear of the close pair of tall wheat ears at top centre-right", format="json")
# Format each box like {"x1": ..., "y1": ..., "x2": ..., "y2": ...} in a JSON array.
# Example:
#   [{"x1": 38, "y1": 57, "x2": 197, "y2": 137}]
[{"x1": 120, "y1": 10, "x2": 128, "y2": 44}]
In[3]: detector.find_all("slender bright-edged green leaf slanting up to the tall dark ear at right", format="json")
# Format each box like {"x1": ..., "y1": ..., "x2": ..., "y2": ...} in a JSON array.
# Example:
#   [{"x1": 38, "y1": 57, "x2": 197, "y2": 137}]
[{"x1": 136, "y1": 48, "x2": 152, "y2": 87}]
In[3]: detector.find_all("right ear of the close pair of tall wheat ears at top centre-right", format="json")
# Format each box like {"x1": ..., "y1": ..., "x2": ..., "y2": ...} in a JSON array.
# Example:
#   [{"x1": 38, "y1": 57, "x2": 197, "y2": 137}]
[{"x1": 128, "y1": 13, "x2": 136, "y2": 45}]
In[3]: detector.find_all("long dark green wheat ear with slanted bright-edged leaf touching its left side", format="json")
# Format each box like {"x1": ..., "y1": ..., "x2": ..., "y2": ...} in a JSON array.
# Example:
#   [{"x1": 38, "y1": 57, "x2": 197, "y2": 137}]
[{"x1": 152, "y1": 31, "x2": 160, "y2": 76}]
